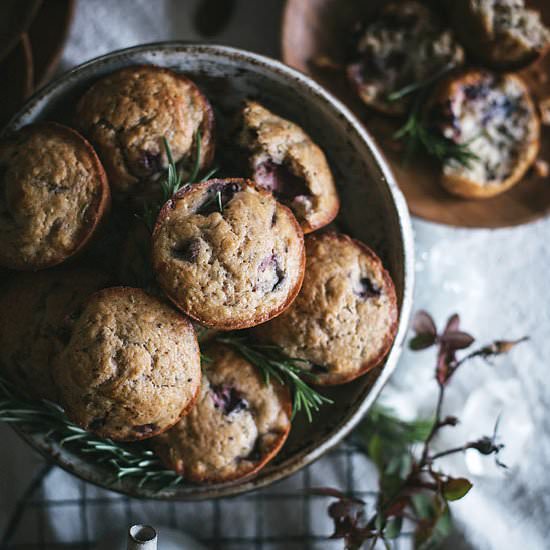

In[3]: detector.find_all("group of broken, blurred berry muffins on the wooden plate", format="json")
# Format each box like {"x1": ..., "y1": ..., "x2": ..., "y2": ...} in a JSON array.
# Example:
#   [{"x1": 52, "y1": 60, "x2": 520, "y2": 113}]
[{"x1": 347, "y1": 0, "x2": 550, "y2": 199}]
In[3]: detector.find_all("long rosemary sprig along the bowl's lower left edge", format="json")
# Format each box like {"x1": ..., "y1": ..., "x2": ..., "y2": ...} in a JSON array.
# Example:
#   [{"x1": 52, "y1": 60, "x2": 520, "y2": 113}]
[{"x1": 0, "y1": 376, "x2": 183, "y2": 491}]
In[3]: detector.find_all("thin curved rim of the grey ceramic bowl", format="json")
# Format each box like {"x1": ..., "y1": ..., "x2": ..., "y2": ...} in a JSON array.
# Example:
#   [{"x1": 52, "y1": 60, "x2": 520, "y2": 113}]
[{"x1": 6, "y1": 40, "x2": 414, "y2": 501}]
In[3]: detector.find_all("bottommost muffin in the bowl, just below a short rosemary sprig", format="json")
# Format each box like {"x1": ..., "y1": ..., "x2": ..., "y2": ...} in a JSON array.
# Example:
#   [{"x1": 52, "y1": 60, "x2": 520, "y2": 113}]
[{"x1": 151, "y1": 344, "x2": 292, "y2": 483}]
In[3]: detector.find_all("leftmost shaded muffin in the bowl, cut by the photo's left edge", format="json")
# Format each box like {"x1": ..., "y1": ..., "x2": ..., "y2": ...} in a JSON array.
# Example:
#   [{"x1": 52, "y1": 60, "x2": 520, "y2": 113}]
[{"x1": 0, "y1": 122, "x2": 110, "y2": 270}]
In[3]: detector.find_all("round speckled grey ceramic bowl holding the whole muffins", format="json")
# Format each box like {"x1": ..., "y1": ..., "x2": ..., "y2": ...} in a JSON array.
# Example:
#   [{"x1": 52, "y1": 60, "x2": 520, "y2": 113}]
[{"x1": 3, "y1": 42, "x2": 413, "y2": 500}]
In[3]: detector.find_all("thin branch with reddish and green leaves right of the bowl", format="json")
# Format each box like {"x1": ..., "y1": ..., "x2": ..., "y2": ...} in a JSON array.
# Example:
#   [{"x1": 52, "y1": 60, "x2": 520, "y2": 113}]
[{"x1": 314, "y1": 311, "x2": 526, "y2": 550}]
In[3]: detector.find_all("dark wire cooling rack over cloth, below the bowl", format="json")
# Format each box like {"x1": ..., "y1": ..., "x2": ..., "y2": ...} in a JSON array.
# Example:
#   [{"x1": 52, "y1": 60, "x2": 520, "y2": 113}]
[{"x1": 1, "y1": 443, "x2": 384, "y2": 550}]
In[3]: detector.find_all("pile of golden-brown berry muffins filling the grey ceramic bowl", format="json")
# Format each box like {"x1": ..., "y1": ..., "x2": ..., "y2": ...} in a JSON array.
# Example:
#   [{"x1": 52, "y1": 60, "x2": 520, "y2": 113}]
[{"x1": 0, "y1": 66, "x2": 398, "y2": 482}]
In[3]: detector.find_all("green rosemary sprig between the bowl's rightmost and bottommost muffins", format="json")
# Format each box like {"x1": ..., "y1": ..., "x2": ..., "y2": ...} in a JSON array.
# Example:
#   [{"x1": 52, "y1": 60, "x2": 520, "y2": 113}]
[{"x1": 216, "y1": 334, "x2": 333, "y2": 422}]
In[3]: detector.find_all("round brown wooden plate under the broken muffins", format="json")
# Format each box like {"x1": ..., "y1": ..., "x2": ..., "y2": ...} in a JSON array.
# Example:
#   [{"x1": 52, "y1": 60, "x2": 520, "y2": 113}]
[{"x1": 281, "y1": 0, "x2": 550, "y2": 228}]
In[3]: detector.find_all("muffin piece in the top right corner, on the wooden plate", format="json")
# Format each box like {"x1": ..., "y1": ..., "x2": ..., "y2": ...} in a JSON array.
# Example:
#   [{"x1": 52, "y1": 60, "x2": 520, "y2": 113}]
[{"x1": 450, "y1": 0, "x2": 550, "y2": 70}]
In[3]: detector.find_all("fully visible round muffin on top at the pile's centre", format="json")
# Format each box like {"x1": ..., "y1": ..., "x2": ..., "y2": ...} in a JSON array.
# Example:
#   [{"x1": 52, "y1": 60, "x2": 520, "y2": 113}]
[{"x1": 152, "y1": 179, "x2": 305, "y2": 330}]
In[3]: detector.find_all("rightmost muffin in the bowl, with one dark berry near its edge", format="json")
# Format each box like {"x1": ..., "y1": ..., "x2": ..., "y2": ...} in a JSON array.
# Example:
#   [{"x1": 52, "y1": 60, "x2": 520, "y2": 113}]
[{"x1": 254, "y1": 233, "x2": 398, "y2": 385}]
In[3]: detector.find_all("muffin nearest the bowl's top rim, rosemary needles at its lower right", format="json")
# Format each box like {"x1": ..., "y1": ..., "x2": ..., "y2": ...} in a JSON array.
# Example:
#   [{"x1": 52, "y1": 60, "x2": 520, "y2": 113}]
[{"x1": 76, "y1": 65, "x2": 215, "y2": 198}]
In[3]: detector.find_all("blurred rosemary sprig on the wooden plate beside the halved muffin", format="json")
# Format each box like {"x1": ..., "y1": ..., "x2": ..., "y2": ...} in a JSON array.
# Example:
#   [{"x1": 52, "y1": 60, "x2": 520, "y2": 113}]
[{"x1": 393, "y1": 98, "x2": 479, "y2": 168}]
